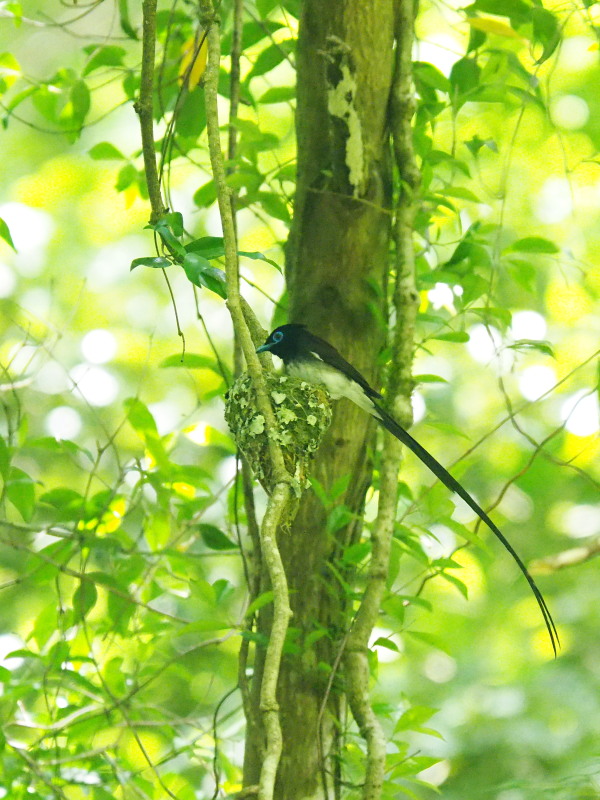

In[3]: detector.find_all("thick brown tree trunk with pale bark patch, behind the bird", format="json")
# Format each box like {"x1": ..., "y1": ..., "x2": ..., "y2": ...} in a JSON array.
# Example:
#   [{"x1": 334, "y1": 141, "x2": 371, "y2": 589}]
[{"x1": 239, "y1": 0, "x2": 394, "y2": 800}]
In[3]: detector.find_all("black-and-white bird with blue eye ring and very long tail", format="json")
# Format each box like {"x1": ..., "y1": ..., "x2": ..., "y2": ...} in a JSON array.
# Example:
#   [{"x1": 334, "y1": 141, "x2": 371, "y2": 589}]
[{"x1": 256, "y1": 323, "x2": 560, "y2": 657}]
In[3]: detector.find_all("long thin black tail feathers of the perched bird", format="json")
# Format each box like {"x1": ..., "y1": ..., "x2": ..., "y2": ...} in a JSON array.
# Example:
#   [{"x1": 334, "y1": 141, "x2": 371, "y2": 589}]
[{"x1": 373, "y1": 402, "x2": 560, "y2": 656}]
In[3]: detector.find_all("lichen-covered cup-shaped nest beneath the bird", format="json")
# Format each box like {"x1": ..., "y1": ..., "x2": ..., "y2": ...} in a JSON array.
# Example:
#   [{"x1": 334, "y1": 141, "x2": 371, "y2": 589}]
[{"x1": 225, "y1": 373, "x2": 331, "y2": 492}]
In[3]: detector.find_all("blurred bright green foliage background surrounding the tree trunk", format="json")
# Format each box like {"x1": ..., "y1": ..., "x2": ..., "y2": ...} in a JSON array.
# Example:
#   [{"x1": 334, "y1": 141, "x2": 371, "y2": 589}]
[{"x1": 0, "y1": 0, "x2": 600, "y2": 800}]
